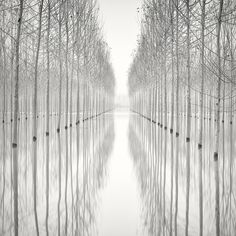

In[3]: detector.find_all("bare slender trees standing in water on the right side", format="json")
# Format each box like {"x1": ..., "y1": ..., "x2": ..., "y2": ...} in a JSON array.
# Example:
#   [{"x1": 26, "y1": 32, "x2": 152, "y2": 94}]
[{"x1": 129, "y1": 0, "x2": 236, "y2": 235}]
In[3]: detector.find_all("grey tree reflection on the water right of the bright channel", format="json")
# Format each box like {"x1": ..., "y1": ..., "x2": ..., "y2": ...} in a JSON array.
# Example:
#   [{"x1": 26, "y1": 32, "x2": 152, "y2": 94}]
[{"x1": 129, "y1": 114, "x2": 236, "y2": 236}]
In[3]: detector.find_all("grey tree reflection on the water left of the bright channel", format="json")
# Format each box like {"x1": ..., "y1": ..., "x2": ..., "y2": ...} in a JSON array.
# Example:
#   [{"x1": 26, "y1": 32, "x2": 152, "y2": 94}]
[{"x1": 0, "y1": 113, "x2": 114, "y2": 235}]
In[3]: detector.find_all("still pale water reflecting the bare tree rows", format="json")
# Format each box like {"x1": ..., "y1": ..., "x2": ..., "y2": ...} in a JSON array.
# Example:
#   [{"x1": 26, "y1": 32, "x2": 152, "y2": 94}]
[{"x1": 0, "y1": 109, "x2": 236, "y2": 236}]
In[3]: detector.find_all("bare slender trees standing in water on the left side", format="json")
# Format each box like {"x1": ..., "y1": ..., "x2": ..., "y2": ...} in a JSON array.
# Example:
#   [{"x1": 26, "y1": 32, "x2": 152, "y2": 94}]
[{"x1": 0, "y1": 0, "x2": 115, "y2": 235}]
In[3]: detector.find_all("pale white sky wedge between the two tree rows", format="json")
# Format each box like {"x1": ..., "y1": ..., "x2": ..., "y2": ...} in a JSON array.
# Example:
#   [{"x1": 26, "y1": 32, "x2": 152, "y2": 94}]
[{"x1": 98, "y1": 0, "x2": 142, "y2": 96}]
